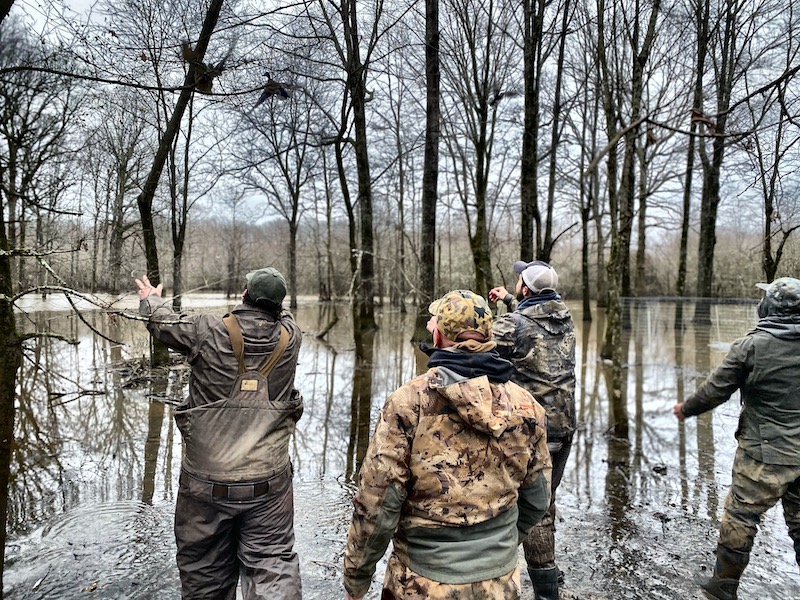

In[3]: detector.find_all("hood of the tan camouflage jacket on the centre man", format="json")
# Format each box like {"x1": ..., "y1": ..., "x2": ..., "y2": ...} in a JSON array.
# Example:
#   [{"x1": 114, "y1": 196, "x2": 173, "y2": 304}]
[{"x1": 428, "y1": 367, "x2": 522, "y2": 438}]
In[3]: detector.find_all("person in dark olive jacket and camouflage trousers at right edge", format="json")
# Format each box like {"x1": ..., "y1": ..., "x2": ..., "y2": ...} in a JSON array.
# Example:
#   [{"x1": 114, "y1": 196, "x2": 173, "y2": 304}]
[{"x1": 673, "y1": 277, "x2": 800, "y2": 600}]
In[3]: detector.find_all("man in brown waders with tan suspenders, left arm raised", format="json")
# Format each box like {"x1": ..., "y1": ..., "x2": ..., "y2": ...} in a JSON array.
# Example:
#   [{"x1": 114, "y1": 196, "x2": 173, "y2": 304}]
[{"x1": 136, "y1": 268, "x2": 303, "y2": 600}]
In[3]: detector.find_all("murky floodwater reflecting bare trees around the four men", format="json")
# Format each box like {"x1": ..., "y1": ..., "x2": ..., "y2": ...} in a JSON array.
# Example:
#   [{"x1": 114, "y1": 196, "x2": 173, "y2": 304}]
[{"x1": 4, "y1": 296, "x2": 800, "y2": 600}]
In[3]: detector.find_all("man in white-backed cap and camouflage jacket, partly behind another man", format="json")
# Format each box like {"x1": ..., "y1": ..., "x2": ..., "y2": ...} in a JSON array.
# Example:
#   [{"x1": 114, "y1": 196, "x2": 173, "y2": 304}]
[{"x1": 489, "y1": 260, "x2": 575, "y2": 600}]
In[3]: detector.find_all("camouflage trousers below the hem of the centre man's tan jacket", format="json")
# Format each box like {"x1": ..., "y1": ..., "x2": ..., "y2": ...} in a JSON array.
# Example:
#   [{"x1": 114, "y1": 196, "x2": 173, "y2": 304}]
[{"x1": 381, "y1": 554, "x2": 521, "y2": 600}]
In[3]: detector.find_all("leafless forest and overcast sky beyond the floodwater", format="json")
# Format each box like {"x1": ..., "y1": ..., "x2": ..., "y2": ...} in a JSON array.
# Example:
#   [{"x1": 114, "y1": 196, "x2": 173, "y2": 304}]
[{"x1": 0, "y1": 0, "x2": 800, "y2": 583}]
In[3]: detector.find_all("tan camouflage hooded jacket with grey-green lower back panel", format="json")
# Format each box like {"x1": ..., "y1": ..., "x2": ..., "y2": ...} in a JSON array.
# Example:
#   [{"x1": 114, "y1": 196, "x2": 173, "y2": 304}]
[{"x1": 344, "y1": 367, "x2": 551, "y2": 598}]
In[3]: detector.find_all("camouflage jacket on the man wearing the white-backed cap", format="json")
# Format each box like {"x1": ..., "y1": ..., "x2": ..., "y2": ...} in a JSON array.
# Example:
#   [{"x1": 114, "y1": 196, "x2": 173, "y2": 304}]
[{"x1": 492, "y1": 299, "x2": 575, "y2": 439}]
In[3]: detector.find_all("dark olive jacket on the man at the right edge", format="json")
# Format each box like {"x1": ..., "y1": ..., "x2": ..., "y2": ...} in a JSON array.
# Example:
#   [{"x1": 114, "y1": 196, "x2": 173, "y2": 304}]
[{"x1": 683, "y1": 316, "x2": 800, "y2": 466}]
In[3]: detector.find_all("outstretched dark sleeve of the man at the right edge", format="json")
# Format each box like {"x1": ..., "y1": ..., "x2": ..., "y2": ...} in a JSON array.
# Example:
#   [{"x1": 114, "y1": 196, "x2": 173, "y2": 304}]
[{"x1": 683, "y1": 336, "x2": 753, "y2": 417}]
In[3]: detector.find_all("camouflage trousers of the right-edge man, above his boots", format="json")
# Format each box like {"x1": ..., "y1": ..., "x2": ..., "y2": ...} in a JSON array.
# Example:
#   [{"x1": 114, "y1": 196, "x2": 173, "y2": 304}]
[{"x1": 719, "y1": 448, "x2": 800, "y2": 564}]
